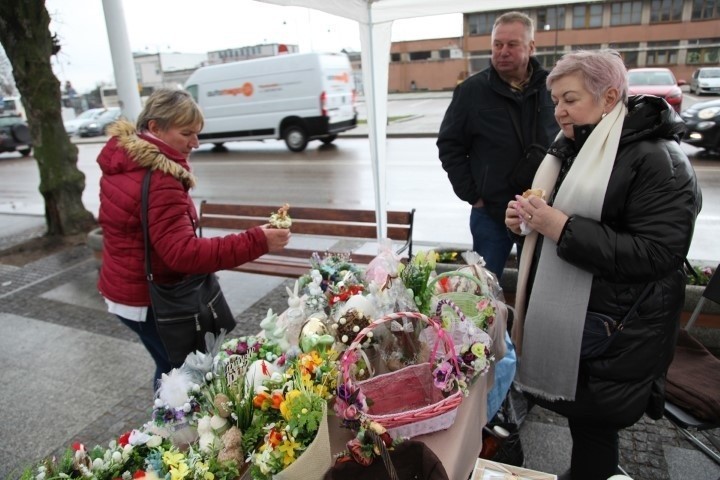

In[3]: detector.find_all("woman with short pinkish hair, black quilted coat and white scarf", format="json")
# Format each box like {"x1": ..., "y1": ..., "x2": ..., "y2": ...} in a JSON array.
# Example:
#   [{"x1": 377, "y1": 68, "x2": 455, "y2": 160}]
[{"x1": 505, "y1": 50, "x2": 701, "y2": 480}]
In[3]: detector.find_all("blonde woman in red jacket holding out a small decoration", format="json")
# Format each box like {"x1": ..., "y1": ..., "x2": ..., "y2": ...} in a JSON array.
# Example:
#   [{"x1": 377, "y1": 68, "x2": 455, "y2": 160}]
[{"x1": 97, "y1": 89, "x2": 290, "y2": 386}]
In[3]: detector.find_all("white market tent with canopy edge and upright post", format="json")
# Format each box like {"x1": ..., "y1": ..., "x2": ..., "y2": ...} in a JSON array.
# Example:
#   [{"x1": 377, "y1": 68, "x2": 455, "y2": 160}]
[{"x1": 257, "y1": 0, "x2": 593, "y2": 239}]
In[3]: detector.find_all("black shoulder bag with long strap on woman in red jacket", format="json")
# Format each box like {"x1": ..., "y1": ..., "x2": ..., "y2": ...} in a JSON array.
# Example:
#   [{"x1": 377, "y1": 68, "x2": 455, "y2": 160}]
[{"x1": 140, "y1": 170, "x2": 235, "y2": 367}]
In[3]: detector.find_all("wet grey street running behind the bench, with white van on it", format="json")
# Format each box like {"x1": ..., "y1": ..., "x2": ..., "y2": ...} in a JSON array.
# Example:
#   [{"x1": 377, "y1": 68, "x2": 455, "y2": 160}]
[{"x1": 0, "y1": 131, "x2": 720, "y2": 264}]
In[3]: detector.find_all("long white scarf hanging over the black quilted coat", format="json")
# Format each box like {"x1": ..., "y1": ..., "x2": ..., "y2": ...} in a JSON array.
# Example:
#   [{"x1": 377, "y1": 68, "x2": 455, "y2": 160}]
[{"x1": 512, "y1": 102, "x2": 627, "y2": 400}]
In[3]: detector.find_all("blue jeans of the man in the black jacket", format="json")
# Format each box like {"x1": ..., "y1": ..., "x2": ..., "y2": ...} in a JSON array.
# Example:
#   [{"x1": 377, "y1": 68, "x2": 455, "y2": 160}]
[{"x1": 470, "y1": 207, "x2": 513, "y2": 280}]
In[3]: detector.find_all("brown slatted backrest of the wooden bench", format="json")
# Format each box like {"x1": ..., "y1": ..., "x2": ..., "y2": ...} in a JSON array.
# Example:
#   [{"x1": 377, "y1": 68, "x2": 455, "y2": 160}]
[{"x1": 200, "y1": 200, "x2": 415, "y2": 256}]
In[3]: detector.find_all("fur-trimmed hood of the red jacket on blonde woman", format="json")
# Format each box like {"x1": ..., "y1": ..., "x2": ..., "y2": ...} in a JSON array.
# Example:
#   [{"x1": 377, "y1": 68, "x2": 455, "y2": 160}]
[{"x1": 99, "y1": 120, "x2": 195, "y2": 189}]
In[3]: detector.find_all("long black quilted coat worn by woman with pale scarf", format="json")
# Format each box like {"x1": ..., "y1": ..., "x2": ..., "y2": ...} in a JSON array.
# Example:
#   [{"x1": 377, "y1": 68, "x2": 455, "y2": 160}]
[{"x1": 543, "y1": 96, "x2": 702, "y2": 428}]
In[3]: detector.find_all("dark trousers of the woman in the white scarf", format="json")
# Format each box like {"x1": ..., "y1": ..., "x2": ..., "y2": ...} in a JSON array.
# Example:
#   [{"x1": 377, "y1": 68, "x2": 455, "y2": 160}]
[{"x1": 568, "y1": 417, "x2": 619, "y2": 480}]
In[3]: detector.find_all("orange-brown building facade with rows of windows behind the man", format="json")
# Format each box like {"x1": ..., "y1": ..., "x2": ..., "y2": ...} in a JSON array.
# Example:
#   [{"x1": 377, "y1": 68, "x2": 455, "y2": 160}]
[{"x1": 389, "y1": 0, "x2": 720, "y2": 92}]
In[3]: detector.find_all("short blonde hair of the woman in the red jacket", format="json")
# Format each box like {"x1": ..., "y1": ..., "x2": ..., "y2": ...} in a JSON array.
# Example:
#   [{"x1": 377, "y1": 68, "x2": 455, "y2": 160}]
[{"x1": 136, "y1": 88, "x2": 205, "y2": 131}]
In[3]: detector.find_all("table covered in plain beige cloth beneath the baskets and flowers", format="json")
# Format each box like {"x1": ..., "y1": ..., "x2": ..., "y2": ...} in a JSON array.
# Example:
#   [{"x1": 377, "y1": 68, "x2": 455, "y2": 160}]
[{"x1": 328, "y1": 369, "x2": 493, "y2": 480}]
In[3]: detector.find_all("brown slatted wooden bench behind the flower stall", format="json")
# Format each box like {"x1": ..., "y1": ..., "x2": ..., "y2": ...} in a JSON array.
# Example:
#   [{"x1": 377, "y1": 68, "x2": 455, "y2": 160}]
[{"x1": 200, "y1": 201, "x2": 415, "y2": 278}]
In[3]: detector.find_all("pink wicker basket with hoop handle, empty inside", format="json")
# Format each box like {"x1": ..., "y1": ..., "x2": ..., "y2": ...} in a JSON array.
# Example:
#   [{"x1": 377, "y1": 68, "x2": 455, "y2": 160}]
[{"x1": 340, "y1": 312, "x2": 463, "y2": 436}]
